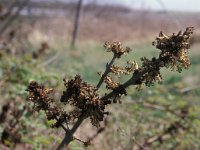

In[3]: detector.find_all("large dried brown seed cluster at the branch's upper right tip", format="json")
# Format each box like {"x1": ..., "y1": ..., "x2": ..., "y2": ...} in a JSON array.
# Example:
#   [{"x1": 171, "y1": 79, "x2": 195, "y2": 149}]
[{"x1": 153, "y1": 27, "x2": 194, "y2": 72}]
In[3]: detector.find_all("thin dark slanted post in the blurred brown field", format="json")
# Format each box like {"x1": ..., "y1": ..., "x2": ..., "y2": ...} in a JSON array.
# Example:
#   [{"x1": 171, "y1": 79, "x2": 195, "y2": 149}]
[{"x1": 71, "y1": 0, "x2": 83, "y2": 48}]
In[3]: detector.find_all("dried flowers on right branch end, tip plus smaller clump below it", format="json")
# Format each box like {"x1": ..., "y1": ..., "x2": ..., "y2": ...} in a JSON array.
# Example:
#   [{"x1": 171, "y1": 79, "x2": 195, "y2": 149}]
[{"x1": 134, "y1": 27, "x2": 194, "y2": 89}]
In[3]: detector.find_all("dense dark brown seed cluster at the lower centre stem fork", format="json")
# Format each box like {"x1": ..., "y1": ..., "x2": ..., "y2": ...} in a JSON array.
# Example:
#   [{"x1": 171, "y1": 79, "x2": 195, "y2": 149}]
[{"x1": 61, "y1": 75, "x2": 106, "y2": 126}]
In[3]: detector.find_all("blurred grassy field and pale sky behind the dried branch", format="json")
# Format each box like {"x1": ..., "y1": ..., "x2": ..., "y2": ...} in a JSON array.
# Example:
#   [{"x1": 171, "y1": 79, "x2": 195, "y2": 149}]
[{"x1": 0, "y1": 0, "x2": 200, "y2": 150}]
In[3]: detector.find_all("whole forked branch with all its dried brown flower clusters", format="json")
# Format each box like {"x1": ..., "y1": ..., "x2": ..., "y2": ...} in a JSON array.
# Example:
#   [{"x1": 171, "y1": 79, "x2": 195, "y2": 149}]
[{"x1": 25, "y1": 27, "x2": 193, "y2": 148}]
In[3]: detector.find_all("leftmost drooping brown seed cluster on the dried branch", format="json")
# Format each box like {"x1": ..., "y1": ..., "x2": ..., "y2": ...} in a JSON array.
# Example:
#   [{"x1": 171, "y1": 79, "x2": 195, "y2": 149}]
[{"x1": 27, "y1": 81, "x2": 68, "y2": 127}]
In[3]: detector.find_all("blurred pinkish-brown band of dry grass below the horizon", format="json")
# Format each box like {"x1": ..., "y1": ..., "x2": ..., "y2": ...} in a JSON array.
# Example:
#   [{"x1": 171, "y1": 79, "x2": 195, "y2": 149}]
[{"x1": 19, "y1": 7, "x2": 200, "y2": 45}]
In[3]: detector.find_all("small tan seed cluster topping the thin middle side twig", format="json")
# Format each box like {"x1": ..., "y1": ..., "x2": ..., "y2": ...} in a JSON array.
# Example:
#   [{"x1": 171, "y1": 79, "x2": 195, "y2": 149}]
[{"x1": 104, "y1": 41, "x2": 131, "y2": 58}]
